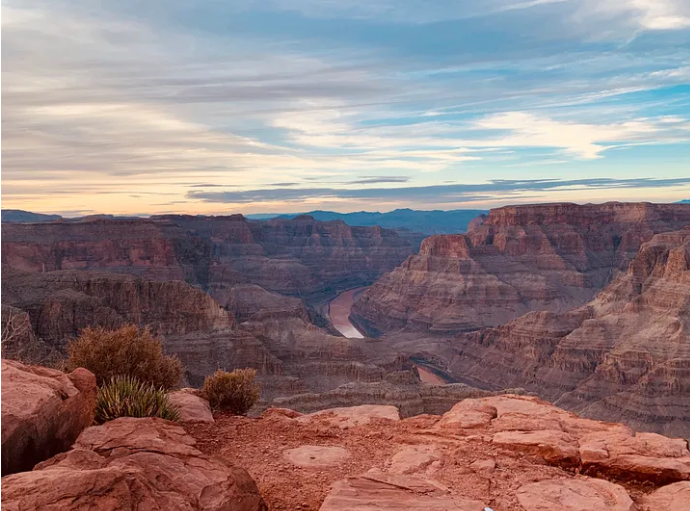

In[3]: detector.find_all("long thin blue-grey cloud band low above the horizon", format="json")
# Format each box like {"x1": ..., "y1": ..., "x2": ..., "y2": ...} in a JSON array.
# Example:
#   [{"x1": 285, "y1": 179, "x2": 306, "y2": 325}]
[{"x1": 187, "y1": 177, "x2": 690, "y2": 204}]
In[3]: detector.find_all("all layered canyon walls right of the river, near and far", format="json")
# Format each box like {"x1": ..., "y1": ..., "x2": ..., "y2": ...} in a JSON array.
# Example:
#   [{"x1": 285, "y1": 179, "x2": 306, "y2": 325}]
[{"x1": 351, "y1": 204, "x2": 690, "y2": 437}]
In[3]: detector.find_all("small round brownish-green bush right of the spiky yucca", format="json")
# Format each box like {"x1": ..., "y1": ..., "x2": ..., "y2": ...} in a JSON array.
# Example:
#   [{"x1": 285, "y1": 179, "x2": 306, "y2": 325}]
[{"x1": 204, "y1": 369, "x2": 261, "y2": 415}]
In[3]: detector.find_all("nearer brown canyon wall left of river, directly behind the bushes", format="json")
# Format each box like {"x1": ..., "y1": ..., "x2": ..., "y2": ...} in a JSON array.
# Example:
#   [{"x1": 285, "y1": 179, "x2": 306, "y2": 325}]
[{"x1": 2, "y1": 269, "x2": 412, "y2": 400}]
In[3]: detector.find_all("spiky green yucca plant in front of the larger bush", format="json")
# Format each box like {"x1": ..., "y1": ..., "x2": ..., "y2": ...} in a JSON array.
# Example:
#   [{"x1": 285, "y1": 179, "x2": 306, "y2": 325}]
[{"x1": 95, "y1": 376, "x2": 180, "y2": 424}]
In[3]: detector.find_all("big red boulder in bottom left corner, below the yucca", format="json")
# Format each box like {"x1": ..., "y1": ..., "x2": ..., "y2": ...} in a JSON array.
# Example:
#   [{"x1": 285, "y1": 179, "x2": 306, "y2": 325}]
[{"x1": 2, "y1": 418, "x2": 267, "y2": 511}]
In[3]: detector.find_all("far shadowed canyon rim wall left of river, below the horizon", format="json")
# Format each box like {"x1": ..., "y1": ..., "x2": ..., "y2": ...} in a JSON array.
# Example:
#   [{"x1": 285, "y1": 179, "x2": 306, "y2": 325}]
[{"x1": 2, "y1": 215, "x2": 413, "y2": 299}]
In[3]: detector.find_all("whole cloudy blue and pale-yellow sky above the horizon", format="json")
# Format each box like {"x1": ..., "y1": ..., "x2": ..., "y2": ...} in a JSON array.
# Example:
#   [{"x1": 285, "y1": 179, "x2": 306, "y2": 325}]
[{"x1": 2, "y1": 0, "x2": 690, "y2": 216}]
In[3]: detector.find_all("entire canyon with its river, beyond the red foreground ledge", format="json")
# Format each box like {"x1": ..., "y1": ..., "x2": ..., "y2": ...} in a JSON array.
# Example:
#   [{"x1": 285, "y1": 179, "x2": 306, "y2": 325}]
[{"x1": 2, "y1": 203, "x2": 690, "y2": 437}]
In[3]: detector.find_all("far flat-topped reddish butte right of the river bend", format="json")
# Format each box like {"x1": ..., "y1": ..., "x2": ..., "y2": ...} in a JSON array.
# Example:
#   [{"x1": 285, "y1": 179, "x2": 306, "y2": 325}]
[{"x1": 351, "y1": 203, "x2": 690, "y2": 335}]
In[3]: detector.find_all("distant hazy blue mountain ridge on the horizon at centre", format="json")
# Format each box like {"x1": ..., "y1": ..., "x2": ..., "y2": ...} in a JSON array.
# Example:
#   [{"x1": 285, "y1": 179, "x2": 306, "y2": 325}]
[{"x1": 246, "y1": 209, "x2": 488, "y2": 235}]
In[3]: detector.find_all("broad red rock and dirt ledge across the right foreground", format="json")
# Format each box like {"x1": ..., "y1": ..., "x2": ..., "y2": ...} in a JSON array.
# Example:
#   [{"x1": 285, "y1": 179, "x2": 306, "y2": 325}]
[{"x1": 181, "y1": 395, "x2": 690, "y2": 511}]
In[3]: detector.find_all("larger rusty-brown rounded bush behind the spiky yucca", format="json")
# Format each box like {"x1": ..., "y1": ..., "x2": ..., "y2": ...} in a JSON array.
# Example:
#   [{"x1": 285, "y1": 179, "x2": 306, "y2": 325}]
[{"x1": 67, "y1": 325, "x2": 182, "y2": 389}]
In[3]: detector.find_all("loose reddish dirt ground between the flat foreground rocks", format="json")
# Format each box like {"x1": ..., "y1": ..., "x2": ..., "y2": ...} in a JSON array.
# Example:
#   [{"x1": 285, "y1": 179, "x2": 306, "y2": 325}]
[{"x1": 186, "y1": 412, "x2": 651, "y2": 511}]
